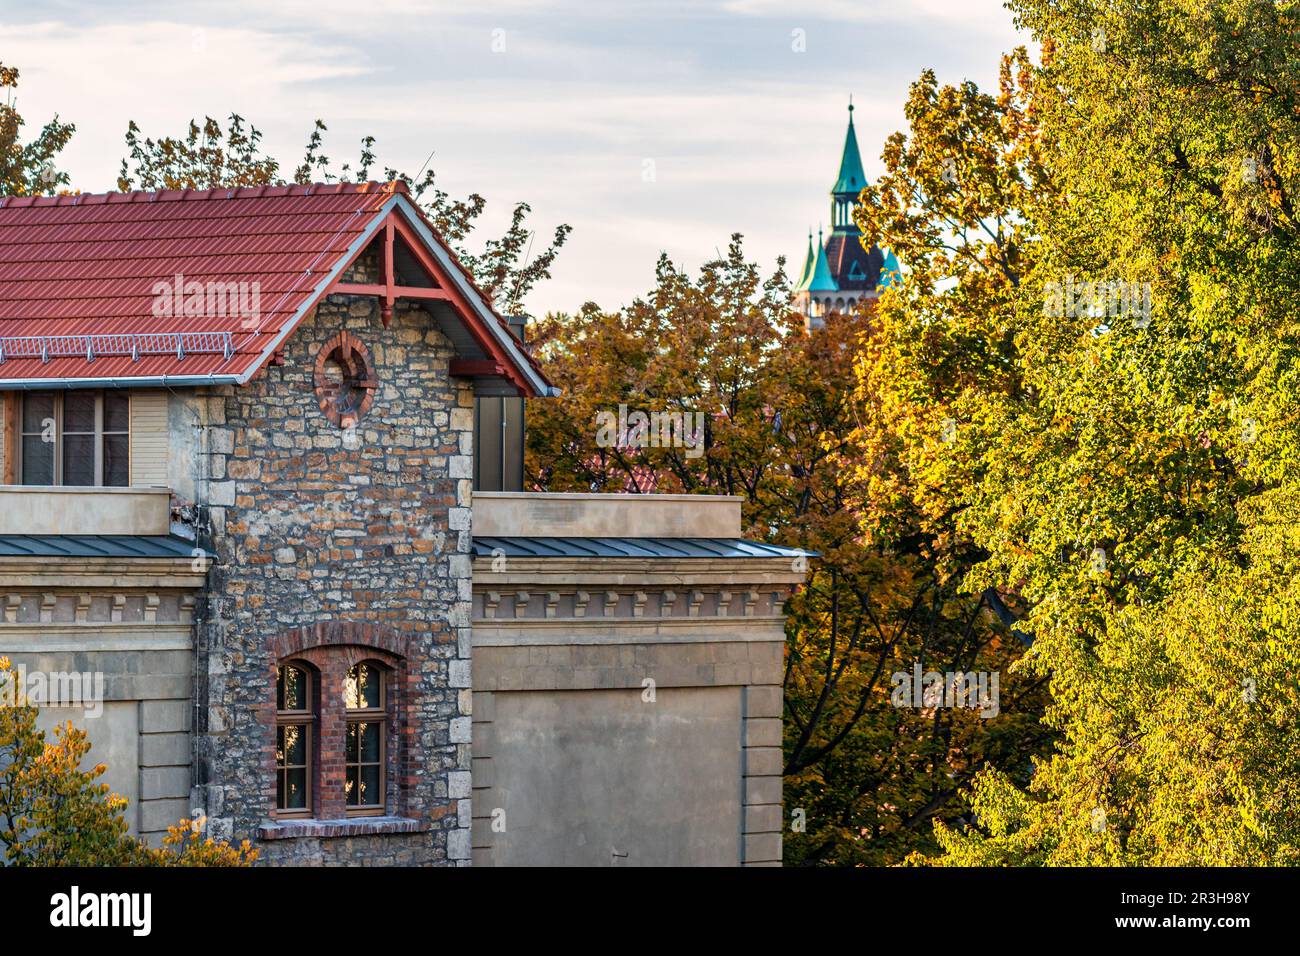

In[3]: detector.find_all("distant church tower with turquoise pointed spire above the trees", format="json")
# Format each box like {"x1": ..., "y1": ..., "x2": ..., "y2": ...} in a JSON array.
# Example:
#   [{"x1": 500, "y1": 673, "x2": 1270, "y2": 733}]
[{"x1": 794, "y1": 99, "x2": 897, "y2": 329}]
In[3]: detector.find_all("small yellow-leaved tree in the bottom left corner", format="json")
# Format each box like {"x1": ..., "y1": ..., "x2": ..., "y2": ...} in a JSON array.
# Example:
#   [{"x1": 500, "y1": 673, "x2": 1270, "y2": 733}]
[{"x1": 0, "y1": 657, "x2": 257, "y2": 866}]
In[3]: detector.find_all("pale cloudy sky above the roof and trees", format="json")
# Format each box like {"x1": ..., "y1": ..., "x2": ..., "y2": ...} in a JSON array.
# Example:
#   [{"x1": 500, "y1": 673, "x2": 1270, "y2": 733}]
[{"x1": 0, "y1": 0, "x2": 1028, "y2": 315}]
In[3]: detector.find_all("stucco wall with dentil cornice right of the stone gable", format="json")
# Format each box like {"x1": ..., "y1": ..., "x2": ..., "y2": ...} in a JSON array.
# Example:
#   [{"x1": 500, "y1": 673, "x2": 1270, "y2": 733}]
[{"x1": 472, "y1": 546, "x2": 802, "y2": 866}]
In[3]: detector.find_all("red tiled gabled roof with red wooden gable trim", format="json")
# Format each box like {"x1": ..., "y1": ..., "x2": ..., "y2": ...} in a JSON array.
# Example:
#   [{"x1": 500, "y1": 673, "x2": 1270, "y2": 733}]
[{"x1": 0, "y1": 182, "x2": 553, "y2": 395}]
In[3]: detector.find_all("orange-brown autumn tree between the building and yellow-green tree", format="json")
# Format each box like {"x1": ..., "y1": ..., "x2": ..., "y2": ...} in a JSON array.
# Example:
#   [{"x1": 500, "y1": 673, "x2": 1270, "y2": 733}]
[{"x1": 525, "y1": 235, "x2": 1041, "y2": 864}]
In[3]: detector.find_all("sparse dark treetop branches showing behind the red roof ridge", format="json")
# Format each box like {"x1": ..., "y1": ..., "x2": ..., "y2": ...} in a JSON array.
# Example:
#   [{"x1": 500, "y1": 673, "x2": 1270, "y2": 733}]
[{"x1": 117, "y1": 113, "x2": 572, "y2": 315}]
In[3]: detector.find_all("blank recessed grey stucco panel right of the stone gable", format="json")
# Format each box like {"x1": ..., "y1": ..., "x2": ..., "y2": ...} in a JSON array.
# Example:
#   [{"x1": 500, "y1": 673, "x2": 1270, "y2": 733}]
[{"x1": 485, "y1": 687, "x2": 742, "y2": 866}]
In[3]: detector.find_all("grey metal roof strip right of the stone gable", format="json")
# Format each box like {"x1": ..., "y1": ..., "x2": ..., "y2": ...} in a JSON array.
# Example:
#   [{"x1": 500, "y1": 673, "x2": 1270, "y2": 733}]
[{"x1": 475, "y1": 536, "x2": 816, "y2": 558}]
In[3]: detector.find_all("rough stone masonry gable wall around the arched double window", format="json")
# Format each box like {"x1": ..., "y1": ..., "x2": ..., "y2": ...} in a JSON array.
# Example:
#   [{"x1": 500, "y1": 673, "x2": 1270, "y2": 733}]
[{"x1": 194, "y1": 254, "x2": 473, "y2": 865}]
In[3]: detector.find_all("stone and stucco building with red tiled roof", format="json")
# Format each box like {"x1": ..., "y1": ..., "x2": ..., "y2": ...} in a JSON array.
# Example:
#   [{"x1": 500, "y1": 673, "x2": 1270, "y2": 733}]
[{"x1": 0, "y1": 183, "x2": 803, "y2": 865}]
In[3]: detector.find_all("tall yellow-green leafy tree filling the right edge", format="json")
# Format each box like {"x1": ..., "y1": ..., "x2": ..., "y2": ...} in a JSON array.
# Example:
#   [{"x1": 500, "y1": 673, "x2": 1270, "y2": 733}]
[{"x1": 889, "y1": 0, "x2": 1300, "y2": 865}]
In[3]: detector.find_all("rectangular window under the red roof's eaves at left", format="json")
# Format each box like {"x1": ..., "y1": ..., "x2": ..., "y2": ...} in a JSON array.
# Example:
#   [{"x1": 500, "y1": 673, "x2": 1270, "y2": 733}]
[{"x1": 18, "y1": 390, "x2": 131, "y2": 488}]
